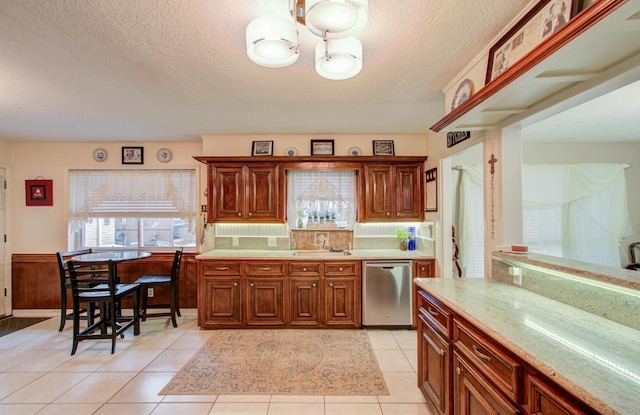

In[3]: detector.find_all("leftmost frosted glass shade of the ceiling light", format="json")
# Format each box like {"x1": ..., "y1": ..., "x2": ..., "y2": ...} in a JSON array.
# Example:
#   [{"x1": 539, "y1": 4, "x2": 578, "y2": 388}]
[{"x1": 247, "y1": 16, "x2": 300, "y2": 68}]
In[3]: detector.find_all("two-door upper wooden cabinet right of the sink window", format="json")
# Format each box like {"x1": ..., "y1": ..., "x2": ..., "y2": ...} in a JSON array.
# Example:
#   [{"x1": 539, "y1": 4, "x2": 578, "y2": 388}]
[{"x1": 360, "y1": 163, "x2": 424, "y2": 222}]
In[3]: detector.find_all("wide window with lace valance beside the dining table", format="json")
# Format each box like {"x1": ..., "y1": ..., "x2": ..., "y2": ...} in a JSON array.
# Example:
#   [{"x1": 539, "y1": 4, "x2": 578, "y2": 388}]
[{"x1": 69, "y1": 169, "x2": 196, "y2": 249}]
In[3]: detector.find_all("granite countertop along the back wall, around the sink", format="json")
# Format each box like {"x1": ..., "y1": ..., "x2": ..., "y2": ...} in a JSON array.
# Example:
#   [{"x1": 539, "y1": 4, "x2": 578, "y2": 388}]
[{"x1": 196, "y1": 249, "x2": 433, "y2": 260}]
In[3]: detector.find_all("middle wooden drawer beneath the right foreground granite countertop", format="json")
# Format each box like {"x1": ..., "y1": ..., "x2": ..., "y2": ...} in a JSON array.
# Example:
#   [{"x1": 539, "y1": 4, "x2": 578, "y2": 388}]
[{"x1": 453, "y1": 319, "x2": 522, "y2": 402}]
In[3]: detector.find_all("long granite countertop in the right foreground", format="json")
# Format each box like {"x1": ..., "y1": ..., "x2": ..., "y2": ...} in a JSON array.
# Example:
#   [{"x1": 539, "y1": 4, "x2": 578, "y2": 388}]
[{"x1": 415, "y1": 278, "x2": 640, "y2": 414}]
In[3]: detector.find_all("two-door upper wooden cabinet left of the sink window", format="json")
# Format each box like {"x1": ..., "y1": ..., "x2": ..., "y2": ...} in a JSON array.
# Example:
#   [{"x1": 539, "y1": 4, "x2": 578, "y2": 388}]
[{"x1": 209, "y1": 163, "x2": 284, "y2": 222}]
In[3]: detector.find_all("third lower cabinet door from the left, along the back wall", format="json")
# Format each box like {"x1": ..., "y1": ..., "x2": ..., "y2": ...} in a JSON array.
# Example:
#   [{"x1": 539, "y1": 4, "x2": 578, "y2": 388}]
[{"x1": 289, "y1": 278, "x2": 320, "y2": 326}]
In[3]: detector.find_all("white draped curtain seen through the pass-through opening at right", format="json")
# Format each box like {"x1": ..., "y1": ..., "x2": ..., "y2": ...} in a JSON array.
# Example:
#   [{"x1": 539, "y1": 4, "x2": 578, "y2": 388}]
[{"x1": 522, "y1": 163, "x2": 633, "y2": 267}]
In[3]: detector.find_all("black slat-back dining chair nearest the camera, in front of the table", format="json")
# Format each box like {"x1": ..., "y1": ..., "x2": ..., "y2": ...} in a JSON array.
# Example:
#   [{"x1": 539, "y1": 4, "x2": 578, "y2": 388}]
[{"x1": 67, "y1": 260, "x2": 140, "y2": 355}]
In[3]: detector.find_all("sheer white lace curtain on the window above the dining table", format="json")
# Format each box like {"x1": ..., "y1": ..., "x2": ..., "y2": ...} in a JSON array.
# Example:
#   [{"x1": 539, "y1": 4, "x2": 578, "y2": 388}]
[{"x1": 69, "y1": 169, "x2": 196, "y2": 231}]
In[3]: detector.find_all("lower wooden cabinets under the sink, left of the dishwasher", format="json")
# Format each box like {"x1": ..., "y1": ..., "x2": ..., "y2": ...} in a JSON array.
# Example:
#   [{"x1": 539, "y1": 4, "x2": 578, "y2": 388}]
[{"x1": 198, "y1": 260, "x2": 361, "y2": 329}]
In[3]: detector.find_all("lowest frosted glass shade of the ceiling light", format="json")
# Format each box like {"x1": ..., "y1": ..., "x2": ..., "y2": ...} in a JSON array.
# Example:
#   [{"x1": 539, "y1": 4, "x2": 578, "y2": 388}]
[{"x1": 316, "y1": 37, "x2": 362, "y2": 80}]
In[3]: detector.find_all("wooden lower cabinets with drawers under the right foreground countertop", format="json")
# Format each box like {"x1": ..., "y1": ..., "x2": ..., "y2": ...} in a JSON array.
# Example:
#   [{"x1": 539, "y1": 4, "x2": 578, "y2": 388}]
[{"x1": 416, "y1": 287, "x2": 598, "y2": 415}]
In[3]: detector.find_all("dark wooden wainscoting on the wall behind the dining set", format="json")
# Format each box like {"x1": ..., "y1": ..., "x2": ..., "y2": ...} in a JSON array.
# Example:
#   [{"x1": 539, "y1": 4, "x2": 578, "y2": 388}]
[{"x1": 11, "y1": 252, "x2": 198, "y2": 310}]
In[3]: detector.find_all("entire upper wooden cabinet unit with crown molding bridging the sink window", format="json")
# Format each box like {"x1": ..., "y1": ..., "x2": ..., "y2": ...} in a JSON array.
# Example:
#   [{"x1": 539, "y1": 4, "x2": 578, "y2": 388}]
[{"x1": 194, "y1": 156, "x2": 427, "y2": 223}]
